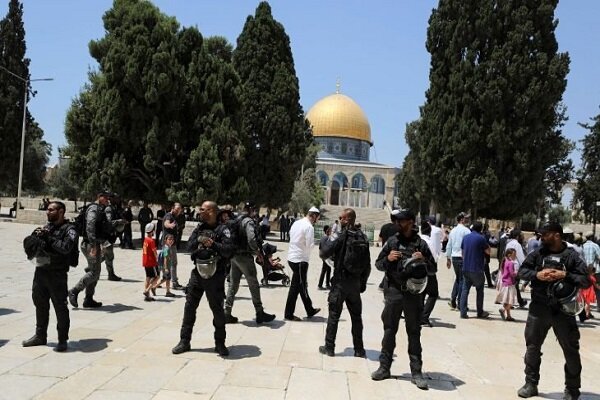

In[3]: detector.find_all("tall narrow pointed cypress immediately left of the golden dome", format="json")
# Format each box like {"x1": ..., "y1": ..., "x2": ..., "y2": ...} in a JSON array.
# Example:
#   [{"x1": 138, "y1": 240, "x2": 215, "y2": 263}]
[{"x1": 233, "y1": 2, "x2": 313, "y2": 208}]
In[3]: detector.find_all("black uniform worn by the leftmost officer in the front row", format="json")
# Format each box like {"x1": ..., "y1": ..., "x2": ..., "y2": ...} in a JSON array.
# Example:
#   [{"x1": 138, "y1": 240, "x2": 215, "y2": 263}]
[{"x1": 26, "y1": 222, "x2": 79, "y2": 343}]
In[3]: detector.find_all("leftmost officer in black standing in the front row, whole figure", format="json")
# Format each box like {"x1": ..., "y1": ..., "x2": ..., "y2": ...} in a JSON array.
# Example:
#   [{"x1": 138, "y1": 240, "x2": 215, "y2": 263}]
[{"x1": 23, "y1": 201, "x2": 79, "y2": 352}]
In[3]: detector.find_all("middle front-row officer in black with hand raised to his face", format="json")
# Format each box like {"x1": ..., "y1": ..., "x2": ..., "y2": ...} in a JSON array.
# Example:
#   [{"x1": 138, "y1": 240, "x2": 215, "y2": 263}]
[{"x1": 319, "y1": 208, "x2": 371, "y2": 358}]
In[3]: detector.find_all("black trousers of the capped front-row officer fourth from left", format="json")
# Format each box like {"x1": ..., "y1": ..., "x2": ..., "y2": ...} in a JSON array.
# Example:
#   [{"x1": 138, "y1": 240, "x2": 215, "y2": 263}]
[{"x1": 379, "y1": 285, "x2": 423, "y2": 374}]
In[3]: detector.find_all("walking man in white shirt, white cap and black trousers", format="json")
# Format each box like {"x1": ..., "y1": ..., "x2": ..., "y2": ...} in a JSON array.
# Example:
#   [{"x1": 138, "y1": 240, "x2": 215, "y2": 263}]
[{"x1": 284, "y1": 207, "x2": 321, "y2": 321}]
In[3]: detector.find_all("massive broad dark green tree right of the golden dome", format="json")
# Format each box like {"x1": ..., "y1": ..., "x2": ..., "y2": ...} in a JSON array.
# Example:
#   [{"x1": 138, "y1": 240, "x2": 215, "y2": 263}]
[{"x1": 411, "y1": 0, "x2": 569, "y2": 219}]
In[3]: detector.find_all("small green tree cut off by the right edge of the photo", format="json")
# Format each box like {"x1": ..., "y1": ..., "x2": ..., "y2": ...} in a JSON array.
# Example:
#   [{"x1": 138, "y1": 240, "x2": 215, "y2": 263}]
[{"x1": 574, "y1": 109, "x2": 600, "y2": 220}]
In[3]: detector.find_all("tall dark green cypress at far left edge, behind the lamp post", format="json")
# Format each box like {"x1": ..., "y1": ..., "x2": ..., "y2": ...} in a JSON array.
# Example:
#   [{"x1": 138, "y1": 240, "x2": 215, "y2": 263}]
[{"x1": 0, "y1": 0, "x2": 52, "y2": 193}]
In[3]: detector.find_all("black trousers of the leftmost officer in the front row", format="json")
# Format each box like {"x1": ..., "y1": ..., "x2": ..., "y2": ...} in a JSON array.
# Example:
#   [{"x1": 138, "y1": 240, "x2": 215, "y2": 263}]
[{"x1": 31, "y1": 267, "x2": 71, "y2": 342}]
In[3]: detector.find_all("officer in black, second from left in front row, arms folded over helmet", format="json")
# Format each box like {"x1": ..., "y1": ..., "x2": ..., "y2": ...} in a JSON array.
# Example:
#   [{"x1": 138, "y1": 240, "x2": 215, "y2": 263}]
[{"x1": 172, "y1": 201, "x2": 236, "y2": 356}]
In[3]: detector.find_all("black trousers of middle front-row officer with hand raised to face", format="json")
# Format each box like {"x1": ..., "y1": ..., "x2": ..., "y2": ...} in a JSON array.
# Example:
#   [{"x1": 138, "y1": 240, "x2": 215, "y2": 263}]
[{"x1": 325, "y1": 277, "x2": 365, "y2": 350}]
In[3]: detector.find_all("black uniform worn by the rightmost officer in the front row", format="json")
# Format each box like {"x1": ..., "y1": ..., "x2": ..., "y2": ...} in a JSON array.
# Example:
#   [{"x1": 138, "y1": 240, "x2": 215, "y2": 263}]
[{"x1": 518, "y1": 242, "x2": 591, "y2": 393}]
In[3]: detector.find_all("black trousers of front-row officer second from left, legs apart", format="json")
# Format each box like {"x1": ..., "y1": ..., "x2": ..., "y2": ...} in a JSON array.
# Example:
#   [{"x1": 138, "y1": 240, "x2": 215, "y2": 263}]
[{"x1": 180, "y1": 268, "x2": 225, "y2": 344}]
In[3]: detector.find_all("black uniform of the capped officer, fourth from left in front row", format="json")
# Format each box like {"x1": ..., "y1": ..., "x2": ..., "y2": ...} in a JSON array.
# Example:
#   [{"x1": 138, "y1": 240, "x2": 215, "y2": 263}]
[{"x1": 375, "y1": 230, "x2": 436, "y2": 375}]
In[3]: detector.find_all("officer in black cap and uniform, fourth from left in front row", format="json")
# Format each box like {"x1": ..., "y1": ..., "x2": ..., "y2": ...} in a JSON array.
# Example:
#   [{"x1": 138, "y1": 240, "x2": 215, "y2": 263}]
[{"x1": 371, "y1": 210, "x2": 435, "y2": 390}]
